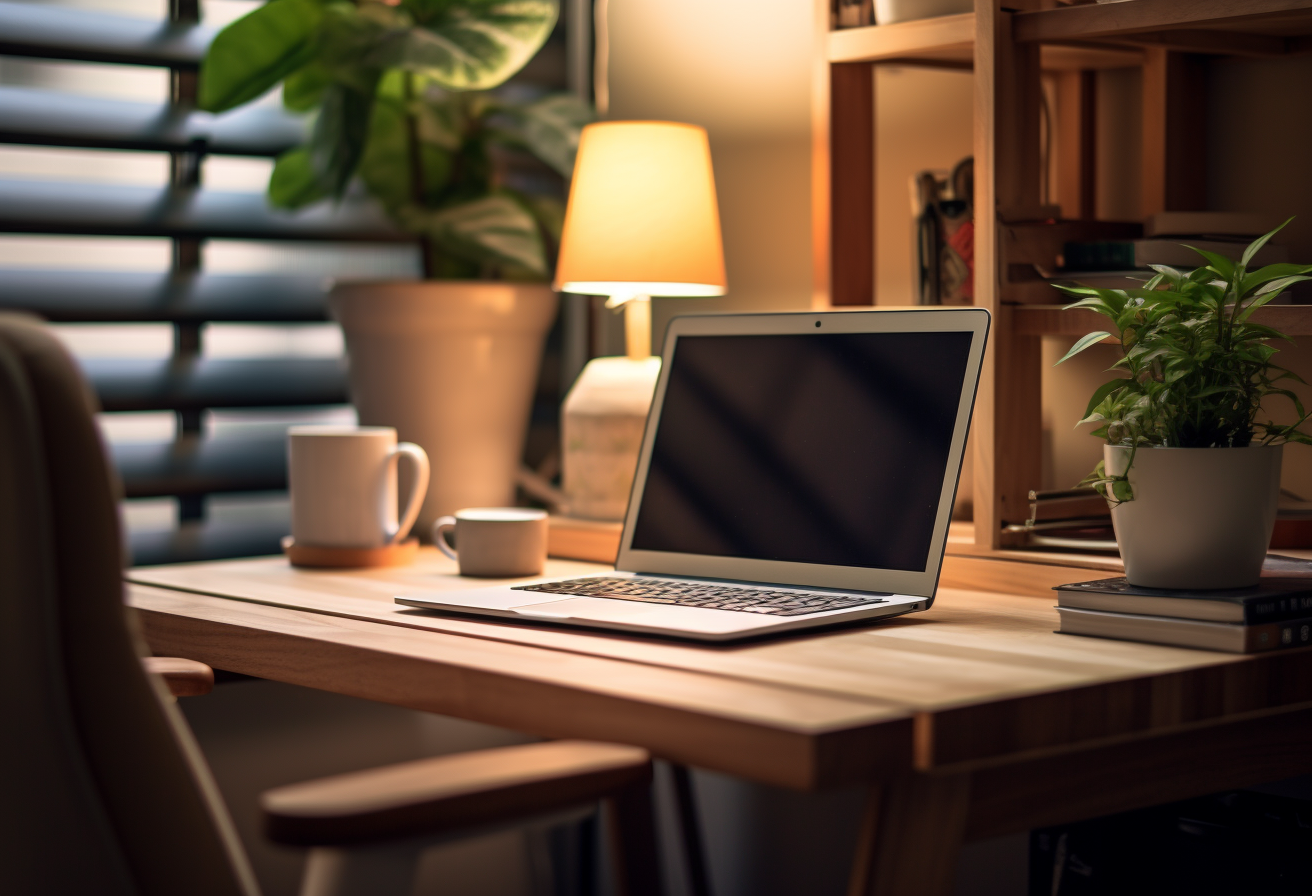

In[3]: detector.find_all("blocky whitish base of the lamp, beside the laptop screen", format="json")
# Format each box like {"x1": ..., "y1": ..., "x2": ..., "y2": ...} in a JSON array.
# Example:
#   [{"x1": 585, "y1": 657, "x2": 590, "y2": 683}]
[{"x1": 560, "y1": 357, "x2": 660, "y2": 521}]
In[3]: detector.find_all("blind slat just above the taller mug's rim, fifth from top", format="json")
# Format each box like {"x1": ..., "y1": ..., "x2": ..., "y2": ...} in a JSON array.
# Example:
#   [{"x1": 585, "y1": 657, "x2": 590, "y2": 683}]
[{"x1": 81, "y1": 358, "x2": 348, "y2": 411}]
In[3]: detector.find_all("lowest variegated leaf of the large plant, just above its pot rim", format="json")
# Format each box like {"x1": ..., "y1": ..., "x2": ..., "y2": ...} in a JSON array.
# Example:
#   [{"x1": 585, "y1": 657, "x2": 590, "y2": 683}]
[{"x1": 408, "y1": 194, "x2": 547, "y2": 277}]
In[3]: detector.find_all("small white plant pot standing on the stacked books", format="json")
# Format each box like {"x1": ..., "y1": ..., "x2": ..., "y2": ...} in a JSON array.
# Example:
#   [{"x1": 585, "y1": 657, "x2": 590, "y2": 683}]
[{"x1": 1102, "y1": 445, "x2": 1283, "y2": 589}]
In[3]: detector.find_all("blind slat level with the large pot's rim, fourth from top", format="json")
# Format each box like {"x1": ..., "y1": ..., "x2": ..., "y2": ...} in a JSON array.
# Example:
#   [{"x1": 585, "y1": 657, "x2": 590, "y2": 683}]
[{"x1": 0, "y1": 269, "x2": 332, "y2": 323}]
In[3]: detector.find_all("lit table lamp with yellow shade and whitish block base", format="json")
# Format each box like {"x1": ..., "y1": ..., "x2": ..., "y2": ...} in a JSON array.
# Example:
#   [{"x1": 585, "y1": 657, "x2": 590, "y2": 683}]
[{"x1": 554, "y1": 122, "x2": 726, "y2": 519}]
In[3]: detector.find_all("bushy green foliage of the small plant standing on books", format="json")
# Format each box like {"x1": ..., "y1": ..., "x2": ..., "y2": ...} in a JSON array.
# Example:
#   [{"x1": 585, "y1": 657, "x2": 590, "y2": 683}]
[{"x1": 1057, "y1": 218, "x2": 1312, "y2": 504}]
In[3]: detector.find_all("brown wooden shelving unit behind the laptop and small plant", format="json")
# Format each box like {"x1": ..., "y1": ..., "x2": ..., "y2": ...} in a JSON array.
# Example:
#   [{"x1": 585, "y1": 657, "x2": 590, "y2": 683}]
[{"x1": 812, "y1": 0, "x2": 1312, "y2": 551}]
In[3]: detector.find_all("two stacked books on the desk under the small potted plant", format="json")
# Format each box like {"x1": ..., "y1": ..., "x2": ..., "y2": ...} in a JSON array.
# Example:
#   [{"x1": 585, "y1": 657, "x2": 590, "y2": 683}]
[{"x1": 1054, "y1": 577, "x2": 1312, "y2": 653}]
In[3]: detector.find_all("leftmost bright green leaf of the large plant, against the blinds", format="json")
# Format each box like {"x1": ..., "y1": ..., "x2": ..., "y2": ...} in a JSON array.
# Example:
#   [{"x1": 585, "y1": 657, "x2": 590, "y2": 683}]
[{"x1": 199, "y1": 0, "x2": 320, "y2": 112}]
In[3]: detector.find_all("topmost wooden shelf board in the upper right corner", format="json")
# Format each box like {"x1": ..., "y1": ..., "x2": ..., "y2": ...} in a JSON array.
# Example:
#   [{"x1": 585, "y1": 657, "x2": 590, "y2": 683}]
[{"x1": 1013, "y1": 0, "x2": 1312, "y2": 55}]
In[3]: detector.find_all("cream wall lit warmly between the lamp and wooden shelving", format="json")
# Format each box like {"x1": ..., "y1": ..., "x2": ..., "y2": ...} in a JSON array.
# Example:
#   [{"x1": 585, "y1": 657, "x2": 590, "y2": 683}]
[{"x1": 605, "y1": 0, "x2": 811, "y2": 353}]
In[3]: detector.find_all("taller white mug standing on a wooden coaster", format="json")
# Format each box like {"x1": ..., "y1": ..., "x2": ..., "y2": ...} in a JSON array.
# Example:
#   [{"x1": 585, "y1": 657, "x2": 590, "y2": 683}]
[{"x1": 287, "y1": 426, "x2": 428, "y2": 548}]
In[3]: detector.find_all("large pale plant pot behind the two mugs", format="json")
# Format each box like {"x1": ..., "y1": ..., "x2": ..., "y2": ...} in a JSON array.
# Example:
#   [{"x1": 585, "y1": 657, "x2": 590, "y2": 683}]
[{"x1": 329, "y1": 281, "x2": 556, "y2": 538}]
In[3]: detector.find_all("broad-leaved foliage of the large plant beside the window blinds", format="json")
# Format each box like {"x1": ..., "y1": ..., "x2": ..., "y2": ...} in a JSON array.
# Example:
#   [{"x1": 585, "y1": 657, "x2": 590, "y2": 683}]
[{"x1": 199, "y1": 0, "x2": 592, "y2": 279}]
